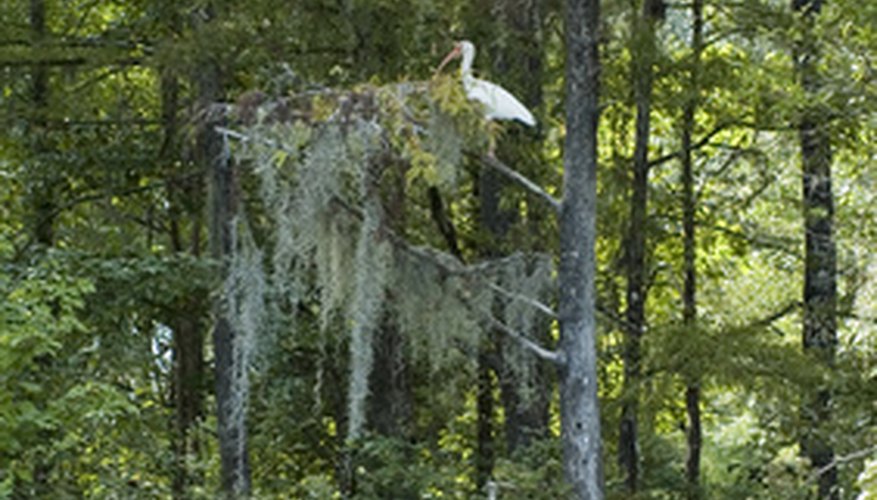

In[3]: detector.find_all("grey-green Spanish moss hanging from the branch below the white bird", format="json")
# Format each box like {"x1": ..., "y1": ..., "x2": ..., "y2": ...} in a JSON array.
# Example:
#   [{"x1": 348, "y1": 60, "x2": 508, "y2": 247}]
[{"x1": 226, "y1": 78, "x2": 552, "y2": 439}]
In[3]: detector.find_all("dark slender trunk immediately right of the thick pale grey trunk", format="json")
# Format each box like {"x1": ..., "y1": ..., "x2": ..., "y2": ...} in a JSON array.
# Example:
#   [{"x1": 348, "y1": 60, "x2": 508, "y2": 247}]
[{"x1": 618, "y1": 0, "x2": 655, "y2": 493}]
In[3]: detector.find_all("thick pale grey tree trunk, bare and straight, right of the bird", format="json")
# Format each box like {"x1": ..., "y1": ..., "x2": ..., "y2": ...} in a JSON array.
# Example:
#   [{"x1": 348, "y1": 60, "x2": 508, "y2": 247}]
[{"x1": 558, "y1": 0, "x2": 604, "y2": 500}]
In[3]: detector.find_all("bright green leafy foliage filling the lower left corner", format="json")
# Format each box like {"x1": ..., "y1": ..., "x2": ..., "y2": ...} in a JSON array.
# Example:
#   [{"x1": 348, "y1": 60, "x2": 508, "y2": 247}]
[{"x1": 0, "y1": 254, "x2": 176, "y2": 497}]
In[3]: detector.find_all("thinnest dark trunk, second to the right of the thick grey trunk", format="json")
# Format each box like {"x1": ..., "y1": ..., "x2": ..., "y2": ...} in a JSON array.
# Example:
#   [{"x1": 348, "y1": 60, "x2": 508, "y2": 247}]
[{"x1": 682, "y1": 0, "x2": 703, "y2": 499}]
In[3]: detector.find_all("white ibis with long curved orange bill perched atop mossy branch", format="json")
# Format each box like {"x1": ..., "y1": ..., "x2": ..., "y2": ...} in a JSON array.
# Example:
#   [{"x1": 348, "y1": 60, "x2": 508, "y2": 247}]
[{"x1": 436, "y1": 40, "x2": 536, "y2": 127}]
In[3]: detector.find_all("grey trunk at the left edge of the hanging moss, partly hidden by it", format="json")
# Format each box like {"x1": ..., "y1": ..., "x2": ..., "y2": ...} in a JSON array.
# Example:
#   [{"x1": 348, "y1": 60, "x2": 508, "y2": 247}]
[{"x1": 194, "y1": 7, "x2": 250, "y2": 498}]
